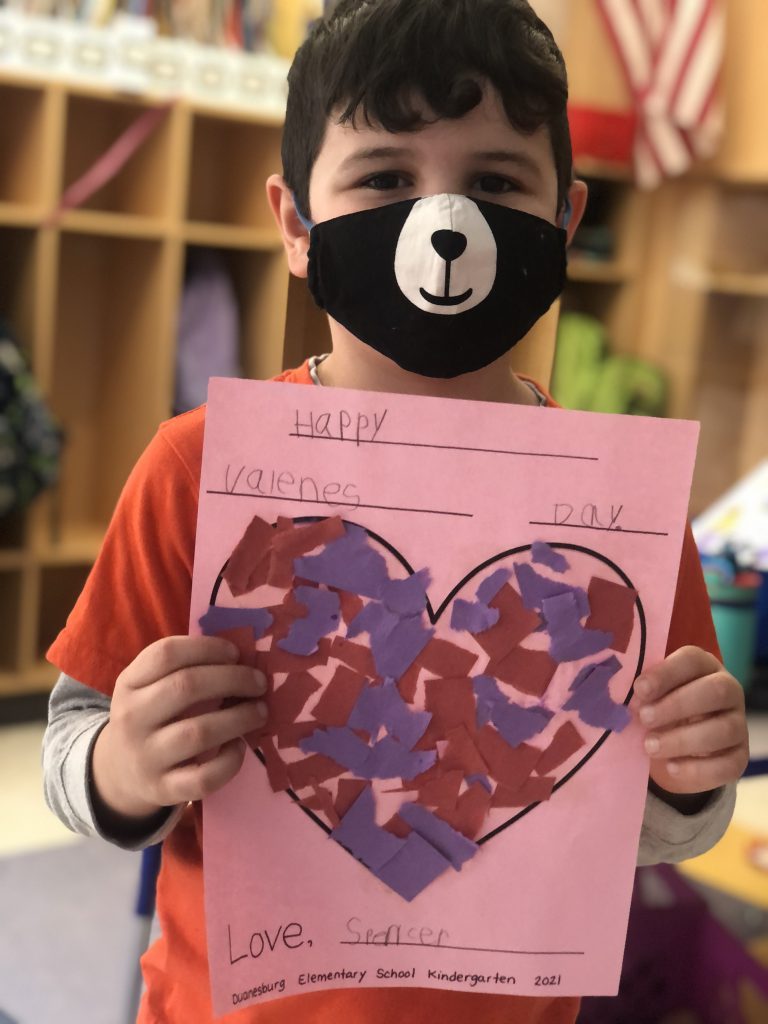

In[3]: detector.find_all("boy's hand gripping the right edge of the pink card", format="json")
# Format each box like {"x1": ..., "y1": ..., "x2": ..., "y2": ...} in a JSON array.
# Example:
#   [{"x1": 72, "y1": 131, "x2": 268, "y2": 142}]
[{"x1": 632, "y1": 647, "x2": 750, "y2": 794}]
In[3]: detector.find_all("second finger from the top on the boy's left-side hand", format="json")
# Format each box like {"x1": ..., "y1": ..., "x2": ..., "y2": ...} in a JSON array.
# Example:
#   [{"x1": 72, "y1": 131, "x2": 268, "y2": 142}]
[{"x1": 142, "y1": 665, "x2": 266, "y2": 726}]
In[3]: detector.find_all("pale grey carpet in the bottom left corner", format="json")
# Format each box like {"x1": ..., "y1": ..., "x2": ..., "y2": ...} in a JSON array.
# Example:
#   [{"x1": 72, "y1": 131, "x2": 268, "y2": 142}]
[{"x1": 0, "y1": 840, "x2": 140, "y2": 1024}]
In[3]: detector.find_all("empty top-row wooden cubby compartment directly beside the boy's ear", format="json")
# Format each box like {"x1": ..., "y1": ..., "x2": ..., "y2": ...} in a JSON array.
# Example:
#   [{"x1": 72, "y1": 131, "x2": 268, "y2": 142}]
[{"x1": 186, "y1": 114, "x2": 282, "y2": 229}]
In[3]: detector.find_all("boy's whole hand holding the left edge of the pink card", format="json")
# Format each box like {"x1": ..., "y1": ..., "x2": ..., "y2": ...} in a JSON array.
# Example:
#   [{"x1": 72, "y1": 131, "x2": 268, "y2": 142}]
[{"x1": 92, "y1": 637, "x2": 266, "y2": 819}]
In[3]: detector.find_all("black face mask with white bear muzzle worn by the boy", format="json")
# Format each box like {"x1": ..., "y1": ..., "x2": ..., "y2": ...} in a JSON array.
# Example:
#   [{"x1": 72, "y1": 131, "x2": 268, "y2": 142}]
[{"x1": 309, "y1": 195, "x2": 566, "y2": 378}]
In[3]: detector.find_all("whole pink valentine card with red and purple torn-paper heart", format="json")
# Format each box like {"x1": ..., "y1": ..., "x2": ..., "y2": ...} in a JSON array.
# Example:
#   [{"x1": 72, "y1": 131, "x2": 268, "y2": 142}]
[{"x1": 190, "y1": 380, "x2": 697, "y2": 1015}]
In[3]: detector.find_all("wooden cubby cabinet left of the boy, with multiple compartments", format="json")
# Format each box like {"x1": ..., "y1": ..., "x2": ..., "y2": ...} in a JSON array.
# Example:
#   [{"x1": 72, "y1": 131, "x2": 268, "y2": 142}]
[{"x1": 0, "y1": 78, "x2": 290, "y2": 695}]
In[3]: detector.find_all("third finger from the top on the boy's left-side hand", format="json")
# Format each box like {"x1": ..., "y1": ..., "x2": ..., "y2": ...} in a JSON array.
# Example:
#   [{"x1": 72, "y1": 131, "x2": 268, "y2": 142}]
[{"x1": 150, "y1": 700, "x2": 267, "y2": 770}]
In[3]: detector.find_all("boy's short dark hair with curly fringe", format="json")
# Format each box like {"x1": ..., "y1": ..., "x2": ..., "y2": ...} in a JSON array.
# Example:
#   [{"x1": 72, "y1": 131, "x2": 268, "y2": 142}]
[{"x1": 283, "y1": 0, "x2": 573, "y2": 216}]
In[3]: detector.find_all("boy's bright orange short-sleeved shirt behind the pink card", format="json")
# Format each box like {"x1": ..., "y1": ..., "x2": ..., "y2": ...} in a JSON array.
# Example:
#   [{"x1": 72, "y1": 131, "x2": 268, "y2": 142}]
[{"x1": 48, "y1": 364, "x2": 718, "y2": 1024}]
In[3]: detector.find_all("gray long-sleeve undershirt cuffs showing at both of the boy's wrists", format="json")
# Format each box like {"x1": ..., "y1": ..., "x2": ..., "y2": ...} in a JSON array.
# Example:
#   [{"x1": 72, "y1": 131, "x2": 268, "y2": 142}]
[{"x1": 43, "y1": 675, "x2": 736, "y2": 864}]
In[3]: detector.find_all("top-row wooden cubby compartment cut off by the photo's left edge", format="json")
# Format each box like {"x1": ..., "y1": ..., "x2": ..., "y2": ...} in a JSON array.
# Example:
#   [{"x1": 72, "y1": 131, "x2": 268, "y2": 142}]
[{"x1": 0, "y1": 83, "x2": 52, "y2": 207}]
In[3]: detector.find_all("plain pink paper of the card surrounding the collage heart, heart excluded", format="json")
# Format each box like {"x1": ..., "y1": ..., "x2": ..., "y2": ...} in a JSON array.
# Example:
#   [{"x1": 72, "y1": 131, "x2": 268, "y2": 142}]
[{"x1": 190, "y1": 381, "x2": 697, "y2": 1014}]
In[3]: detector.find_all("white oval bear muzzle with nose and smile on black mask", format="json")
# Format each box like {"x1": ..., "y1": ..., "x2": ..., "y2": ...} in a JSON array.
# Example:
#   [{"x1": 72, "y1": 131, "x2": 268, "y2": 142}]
[{"x1": 394, "y1": 195, "x2": 497, "y2": 315}]
